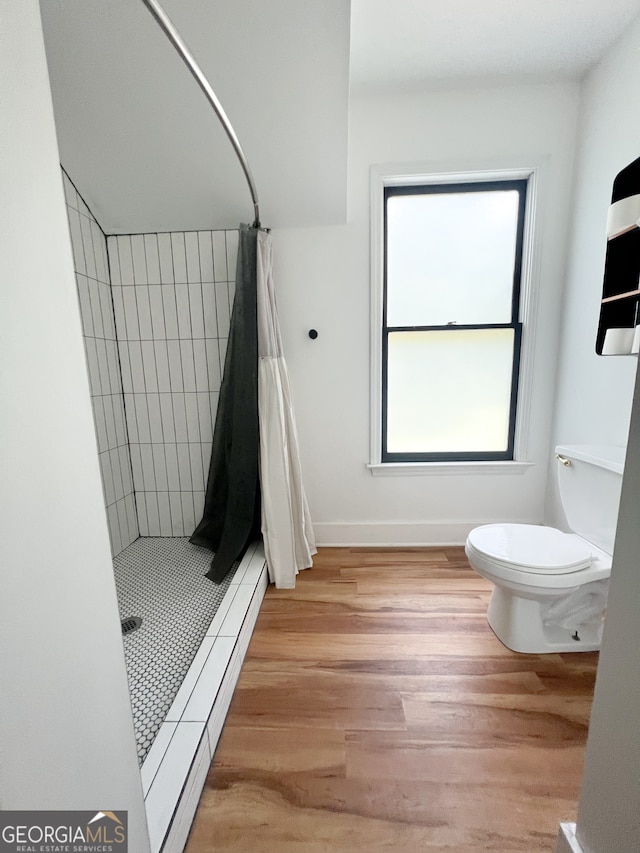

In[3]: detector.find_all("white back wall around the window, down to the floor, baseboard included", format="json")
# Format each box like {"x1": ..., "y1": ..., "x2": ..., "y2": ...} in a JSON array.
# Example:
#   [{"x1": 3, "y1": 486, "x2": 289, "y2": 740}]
[{"x1": 275, "y1": 84, "x2": 578, "y2": 544}]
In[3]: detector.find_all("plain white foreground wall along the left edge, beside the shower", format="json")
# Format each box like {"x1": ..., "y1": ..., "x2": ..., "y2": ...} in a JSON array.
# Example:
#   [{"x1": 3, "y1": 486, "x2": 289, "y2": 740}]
[{"x1": 0, "y1": 0, "x2": 149, "y2": 853}]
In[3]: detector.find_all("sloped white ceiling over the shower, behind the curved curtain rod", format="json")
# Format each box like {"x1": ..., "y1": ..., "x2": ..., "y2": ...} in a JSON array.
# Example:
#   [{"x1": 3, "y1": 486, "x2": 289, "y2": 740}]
[{"x1": 40, "y1": 0, "x2": 349, "y2": 234}]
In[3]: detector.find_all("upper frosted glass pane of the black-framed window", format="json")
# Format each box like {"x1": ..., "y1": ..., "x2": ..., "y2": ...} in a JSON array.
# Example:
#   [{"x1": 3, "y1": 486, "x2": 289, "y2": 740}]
[{"x1": 387, "y1": 190, "x2": 519, "y2": 326}]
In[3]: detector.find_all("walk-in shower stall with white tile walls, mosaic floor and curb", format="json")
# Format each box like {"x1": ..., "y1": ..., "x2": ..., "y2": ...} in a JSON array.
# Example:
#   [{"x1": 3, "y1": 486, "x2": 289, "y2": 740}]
[{"x1": 62, "y1": 170, "x2": 267, "y2": 851}]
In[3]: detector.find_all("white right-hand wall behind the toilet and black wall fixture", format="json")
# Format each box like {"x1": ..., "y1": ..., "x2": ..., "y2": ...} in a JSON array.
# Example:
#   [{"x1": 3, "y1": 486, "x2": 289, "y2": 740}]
[{"x1": 547, "y1": 20, "x2": 640, "y2": 525}]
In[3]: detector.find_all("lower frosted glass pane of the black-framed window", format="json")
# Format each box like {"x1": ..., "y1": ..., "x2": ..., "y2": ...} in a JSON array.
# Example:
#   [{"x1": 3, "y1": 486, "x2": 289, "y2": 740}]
[{"x1": 386, "y1": 329, "x2": 515, "y2": 453}]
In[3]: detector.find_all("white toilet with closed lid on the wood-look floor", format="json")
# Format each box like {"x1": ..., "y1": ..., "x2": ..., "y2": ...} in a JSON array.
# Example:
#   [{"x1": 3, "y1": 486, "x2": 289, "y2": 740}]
[{"x1": 465, "y1": 445, "x2": 625, "y2": 654}]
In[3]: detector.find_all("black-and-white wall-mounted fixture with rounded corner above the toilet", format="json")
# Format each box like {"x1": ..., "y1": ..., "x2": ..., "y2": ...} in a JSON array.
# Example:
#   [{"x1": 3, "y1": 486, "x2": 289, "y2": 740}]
[{"x1": 596, "y1": 158, "x2": 640, "y2": 355}]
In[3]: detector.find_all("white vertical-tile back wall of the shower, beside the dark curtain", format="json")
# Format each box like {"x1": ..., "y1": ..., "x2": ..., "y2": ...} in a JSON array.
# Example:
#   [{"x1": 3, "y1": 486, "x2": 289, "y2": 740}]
[{"x1": 107, "y1": 226, "x2": 238, "y2": 536}]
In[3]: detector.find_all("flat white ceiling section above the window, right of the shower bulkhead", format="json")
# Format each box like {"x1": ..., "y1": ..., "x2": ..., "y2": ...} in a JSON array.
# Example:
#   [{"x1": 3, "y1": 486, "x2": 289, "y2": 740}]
[{"x1": 351, "y1": 0, "x2": 640, "y2": 92}]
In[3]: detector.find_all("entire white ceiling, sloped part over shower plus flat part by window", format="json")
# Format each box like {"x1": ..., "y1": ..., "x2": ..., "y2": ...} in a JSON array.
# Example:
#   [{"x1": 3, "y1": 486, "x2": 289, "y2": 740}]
[{"x1": 41, "y1": 0, "x2": 640, "y2": 233}]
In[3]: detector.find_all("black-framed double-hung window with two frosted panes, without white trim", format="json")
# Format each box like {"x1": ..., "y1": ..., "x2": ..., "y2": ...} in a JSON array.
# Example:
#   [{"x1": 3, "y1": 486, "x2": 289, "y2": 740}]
[{"x1": 381, "y1": 180, "x2": 527, "y2": 463}]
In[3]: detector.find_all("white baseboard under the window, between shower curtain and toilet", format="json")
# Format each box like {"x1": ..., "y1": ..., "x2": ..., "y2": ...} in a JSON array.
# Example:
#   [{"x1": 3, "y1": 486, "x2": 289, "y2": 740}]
[{"x1": 313, "y1": 521, "x2": 483, "y2": 547}]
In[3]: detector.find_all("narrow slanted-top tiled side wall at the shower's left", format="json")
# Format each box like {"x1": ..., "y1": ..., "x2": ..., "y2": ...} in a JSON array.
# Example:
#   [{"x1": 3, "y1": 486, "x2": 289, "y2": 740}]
[{"x1": 62, "y1": 170, "x2": 139, "y2": 557}]
